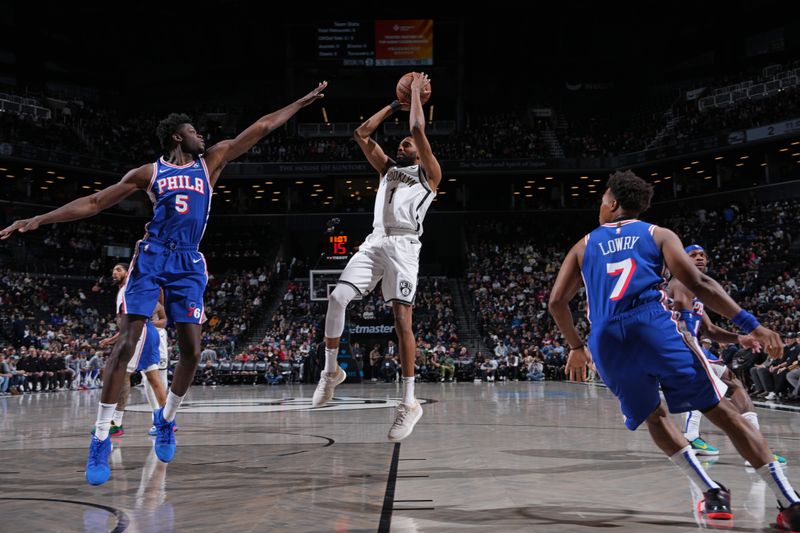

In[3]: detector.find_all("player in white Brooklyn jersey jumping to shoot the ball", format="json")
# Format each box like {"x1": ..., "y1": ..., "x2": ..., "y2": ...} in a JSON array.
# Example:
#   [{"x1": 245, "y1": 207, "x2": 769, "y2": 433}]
[{"x1": 312, "y1": 69, "x2": 442, "y2": 441}]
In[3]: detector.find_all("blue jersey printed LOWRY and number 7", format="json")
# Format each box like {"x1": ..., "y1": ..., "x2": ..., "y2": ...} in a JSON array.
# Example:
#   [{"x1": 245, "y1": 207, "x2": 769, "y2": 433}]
[{"x1": 581, "y1": 220, "x2": 667, "y2": 322}]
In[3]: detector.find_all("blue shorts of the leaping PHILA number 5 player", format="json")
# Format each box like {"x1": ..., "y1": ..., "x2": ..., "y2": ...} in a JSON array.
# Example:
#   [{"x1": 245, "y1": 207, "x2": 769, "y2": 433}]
[{"x1": 123, "y1": 237, "x2": 208, "y2": 324}]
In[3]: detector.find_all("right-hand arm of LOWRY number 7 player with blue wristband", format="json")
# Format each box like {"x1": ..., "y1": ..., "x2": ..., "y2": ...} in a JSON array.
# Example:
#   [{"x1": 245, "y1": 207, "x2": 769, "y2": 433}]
[{"x1": 653, "y1": 228, "x2": 783, "y2": 359}]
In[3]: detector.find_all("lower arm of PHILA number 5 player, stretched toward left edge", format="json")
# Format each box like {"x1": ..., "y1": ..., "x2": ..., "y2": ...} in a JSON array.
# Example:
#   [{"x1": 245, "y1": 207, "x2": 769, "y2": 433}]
[{"x1": 0, "y1": 163, "x2": 153, "y2": 239}]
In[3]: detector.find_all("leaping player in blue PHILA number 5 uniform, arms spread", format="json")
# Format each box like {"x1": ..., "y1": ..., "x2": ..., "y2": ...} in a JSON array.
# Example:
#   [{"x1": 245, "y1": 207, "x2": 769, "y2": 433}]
[{"x1": 0, "y1": 82, "x2": 327, "y2": 485}]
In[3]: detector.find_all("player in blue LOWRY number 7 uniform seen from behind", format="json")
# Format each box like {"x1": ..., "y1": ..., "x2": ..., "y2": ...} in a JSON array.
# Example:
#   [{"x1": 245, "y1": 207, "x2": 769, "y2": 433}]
[{"x1": 550, "y1": 171, "x2": 800, "y2": 531}]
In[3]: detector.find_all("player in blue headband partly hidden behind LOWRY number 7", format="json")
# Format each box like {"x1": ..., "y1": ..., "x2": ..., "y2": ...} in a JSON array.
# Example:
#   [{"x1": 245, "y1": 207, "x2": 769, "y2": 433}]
[{"x1": 668, "y1": 244, "x2": 786, "y2": 464}]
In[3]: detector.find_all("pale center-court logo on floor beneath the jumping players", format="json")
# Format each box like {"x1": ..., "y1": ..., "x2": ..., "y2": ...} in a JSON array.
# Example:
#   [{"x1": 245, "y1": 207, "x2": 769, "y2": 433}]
[{"x1": 126, "y1": 396, "x2": 428, "y2": 414}]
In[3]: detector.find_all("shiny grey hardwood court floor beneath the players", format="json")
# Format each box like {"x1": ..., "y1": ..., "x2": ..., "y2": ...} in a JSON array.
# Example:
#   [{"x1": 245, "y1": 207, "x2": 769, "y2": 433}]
[{"x1": 0, "y1": 382, "x2": 800, "y2": 533}]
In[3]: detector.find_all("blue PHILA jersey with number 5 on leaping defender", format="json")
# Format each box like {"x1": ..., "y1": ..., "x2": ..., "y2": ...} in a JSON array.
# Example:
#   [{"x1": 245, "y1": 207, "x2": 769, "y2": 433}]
[{"x1": 144, "y1": 157, "x2": 212, "y2": 245}]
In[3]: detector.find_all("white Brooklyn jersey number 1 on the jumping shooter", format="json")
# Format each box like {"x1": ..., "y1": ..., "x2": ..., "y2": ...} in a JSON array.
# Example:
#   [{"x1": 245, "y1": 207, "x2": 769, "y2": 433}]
[{"x1": 372, "y1": 165, "x2": 436, "y2": 235}]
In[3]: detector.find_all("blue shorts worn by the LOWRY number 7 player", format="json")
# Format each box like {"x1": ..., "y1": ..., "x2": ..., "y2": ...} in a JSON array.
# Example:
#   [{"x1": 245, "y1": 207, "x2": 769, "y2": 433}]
[{"x1": 589, "y1": 302, "x2": 727, "y2": 430}]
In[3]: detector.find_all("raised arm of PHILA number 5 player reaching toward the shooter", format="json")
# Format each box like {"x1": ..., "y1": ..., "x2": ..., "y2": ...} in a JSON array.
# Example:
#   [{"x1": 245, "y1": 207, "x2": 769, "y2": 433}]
[{"x1": 204, "y1": 81, "x2": 328, "y2": 181}]
